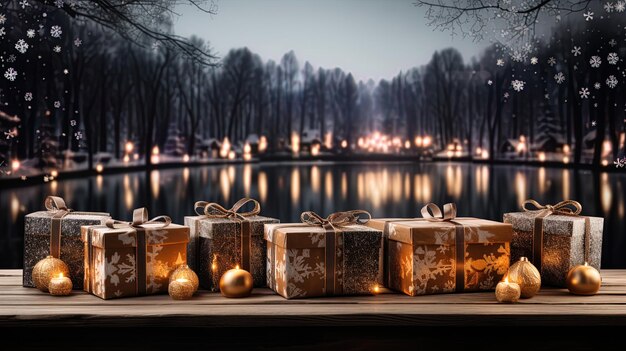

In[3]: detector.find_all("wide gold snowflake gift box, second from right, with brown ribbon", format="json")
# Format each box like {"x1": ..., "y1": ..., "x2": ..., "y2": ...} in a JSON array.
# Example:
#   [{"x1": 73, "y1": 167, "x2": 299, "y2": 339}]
[{"x1": 369, "y1": 204, "x2": 512, "y2": 296}]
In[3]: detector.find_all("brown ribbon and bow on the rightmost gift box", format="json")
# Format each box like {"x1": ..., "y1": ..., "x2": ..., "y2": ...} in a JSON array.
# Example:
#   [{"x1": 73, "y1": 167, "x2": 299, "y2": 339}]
[{"x1": 522, "y1": 199, "x2": 591, "y2": 273}]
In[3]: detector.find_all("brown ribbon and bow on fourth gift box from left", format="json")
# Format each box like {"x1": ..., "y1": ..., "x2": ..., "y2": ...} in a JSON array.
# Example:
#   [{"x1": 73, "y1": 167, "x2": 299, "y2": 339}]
[{"x1": 300, "y1": 210, "x2": 372, "y2": 295}]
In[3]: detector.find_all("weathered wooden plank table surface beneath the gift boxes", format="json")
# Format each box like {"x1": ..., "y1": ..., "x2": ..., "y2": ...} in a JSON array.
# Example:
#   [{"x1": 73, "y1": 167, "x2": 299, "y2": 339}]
[{"x1": 0, "y1": 270, "x2": 626, "y2": 327}]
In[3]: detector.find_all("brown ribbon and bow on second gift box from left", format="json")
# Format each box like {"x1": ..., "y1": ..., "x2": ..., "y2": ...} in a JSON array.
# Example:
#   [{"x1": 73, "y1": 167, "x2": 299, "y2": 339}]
[{"x1": 100, "y1": 207, "x2": 172, "y2": 295}]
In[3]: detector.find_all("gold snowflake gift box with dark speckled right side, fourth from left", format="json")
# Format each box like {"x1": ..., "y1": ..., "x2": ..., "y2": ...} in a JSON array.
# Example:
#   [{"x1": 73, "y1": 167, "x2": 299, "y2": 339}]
[{"x1": 265, "y1": 211, "x2": 382, "y2": 299}]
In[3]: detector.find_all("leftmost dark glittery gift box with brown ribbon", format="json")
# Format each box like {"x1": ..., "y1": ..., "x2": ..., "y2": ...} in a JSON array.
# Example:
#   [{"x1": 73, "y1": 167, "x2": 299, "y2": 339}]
[{"x1": 22, "y1": 196, "x2": 111, "y2": 289}]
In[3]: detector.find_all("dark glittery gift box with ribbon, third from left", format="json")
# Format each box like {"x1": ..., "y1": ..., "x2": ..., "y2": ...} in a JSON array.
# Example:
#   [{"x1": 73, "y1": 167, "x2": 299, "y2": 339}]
[{"x1": 185, "y1": 198, "x2": 279, "y2": 291}]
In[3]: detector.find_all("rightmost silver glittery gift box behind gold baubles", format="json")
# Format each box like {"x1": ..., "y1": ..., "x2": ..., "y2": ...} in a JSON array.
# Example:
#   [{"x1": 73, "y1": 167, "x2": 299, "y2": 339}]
[{"x1": 504, "y1": 200, "x2": 604, "y2": 287}]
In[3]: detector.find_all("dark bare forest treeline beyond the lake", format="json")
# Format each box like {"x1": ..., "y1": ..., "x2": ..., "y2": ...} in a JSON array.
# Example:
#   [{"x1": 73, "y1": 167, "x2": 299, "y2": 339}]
[{"x1": 0, "y1": 6, "x2": 626, "y2": 169}]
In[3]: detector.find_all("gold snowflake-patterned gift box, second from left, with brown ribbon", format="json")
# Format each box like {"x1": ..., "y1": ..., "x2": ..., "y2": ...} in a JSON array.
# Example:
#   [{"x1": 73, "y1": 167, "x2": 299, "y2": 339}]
[{"x1": 81, "y1": 208, "x2": 189, "y2": 299}]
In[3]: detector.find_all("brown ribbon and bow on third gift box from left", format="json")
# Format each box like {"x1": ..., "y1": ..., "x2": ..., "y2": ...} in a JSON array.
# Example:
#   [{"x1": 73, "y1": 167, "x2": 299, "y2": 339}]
[{"x1": 194, "y1": 197, "x2": 261, "y2": 271}]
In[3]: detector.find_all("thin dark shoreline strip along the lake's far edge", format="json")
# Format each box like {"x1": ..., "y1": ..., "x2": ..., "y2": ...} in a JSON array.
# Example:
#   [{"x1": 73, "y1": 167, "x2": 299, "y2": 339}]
[{"x1": 0, "y1": 154, "x2": 626, "y2": 188}]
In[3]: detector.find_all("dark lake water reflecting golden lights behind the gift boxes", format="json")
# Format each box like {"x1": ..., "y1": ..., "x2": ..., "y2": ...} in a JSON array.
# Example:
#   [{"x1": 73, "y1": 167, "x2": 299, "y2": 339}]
[{"x1": 0, "y1": 162, "x2": 626, "y2": 269}]
